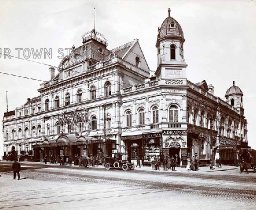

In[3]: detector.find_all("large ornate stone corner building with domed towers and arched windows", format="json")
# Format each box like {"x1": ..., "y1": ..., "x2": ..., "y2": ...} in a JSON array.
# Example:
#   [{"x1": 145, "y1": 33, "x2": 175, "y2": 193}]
[{"x1": 3, "y1": 10, "x2": 247, "y2": 166}]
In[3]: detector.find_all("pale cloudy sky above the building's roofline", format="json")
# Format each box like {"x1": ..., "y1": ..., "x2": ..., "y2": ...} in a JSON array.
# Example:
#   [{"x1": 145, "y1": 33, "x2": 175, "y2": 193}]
[{"x1": 0, "y1": 0, "x2": 256, "y2": 156}]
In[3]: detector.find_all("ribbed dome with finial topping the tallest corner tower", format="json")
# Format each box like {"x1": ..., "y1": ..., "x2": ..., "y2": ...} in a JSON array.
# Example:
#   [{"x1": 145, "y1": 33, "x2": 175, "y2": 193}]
[{"x1": 156, "y1": 8, "x2": 185, "y2": 47}]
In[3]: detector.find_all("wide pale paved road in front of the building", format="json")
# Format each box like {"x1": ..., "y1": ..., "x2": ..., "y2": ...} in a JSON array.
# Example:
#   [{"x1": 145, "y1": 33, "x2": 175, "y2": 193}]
[{"x1": 0, "y1": 163, "x2": 256, "y2": 209}]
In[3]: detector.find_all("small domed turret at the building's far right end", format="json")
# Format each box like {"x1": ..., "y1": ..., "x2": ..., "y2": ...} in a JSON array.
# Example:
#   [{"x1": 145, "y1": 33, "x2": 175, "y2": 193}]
[{"x1": 225, "y1": 81, "x2": 243, "y2": 112}]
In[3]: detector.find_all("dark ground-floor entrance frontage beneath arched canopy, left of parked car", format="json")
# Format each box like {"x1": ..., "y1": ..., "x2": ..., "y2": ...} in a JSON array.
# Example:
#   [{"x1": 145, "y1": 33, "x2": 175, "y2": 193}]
[{"x1": 34, "y1": 135, "x2": 115, "y2": 164}]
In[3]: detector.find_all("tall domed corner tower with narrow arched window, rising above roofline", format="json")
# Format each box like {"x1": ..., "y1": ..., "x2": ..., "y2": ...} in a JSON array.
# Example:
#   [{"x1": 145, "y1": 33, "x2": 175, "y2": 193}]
[{"x1": 155, "y1": 9, "x2": 187, "y2": 79}]
